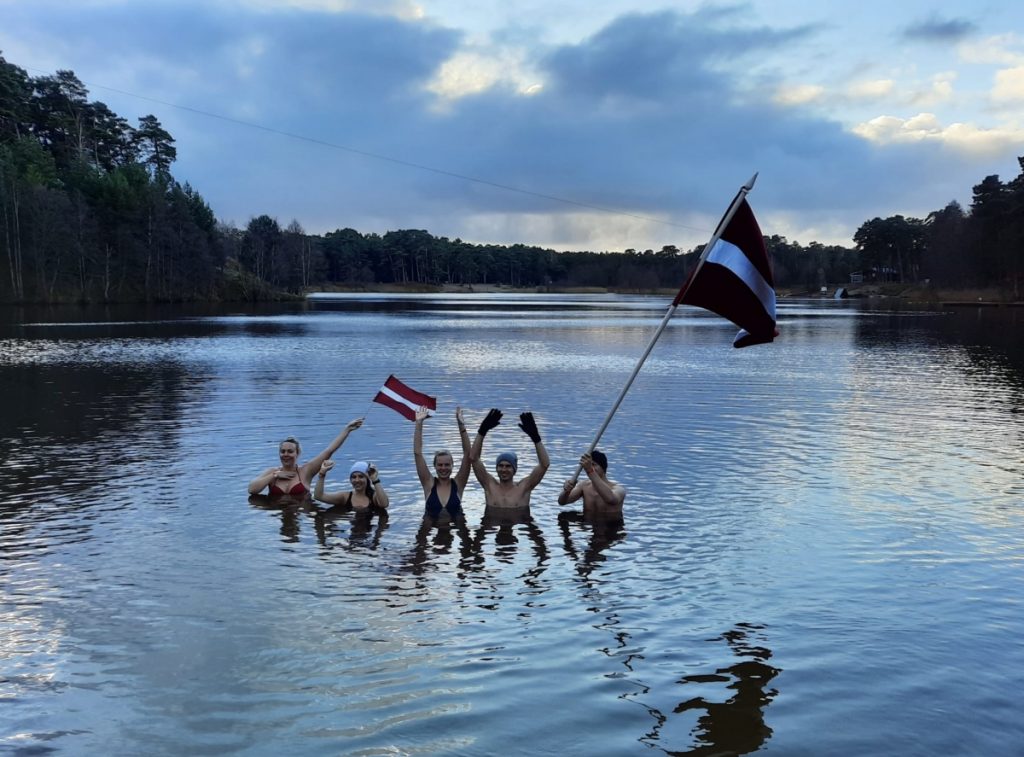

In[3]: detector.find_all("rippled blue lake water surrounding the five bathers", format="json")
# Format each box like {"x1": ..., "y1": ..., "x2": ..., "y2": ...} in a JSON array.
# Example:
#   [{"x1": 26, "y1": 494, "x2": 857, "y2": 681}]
[{"x1": 0, "y1": 295, "x2": 1024, "y2": 757}]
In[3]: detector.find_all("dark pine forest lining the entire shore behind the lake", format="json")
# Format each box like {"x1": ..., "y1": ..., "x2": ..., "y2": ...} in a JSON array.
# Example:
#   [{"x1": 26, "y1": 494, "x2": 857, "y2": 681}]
[{"x1": 0, "y1": 55, "x2": 1024, "y2": 302}]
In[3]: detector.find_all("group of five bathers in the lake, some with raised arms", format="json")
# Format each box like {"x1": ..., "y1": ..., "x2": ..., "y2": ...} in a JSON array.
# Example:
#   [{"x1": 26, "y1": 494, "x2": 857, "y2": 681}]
[{"x1": 249, "y1": 408, "x2": 626, "y2": 522}]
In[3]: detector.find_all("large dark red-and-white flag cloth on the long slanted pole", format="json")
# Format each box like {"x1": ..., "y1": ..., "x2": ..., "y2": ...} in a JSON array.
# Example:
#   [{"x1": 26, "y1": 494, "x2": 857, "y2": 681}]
[{"x1": 673, "y1": 198, "x2": 778, "y2": 347}]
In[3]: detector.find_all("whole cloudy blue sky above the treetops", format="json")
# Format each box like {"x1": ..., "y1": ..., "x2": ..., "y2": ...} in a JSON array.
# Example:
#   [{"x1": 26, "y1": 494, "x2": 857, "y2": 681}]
[{"x1": 0, "y1": 0, "x2": 1024, "y2": 251}]
